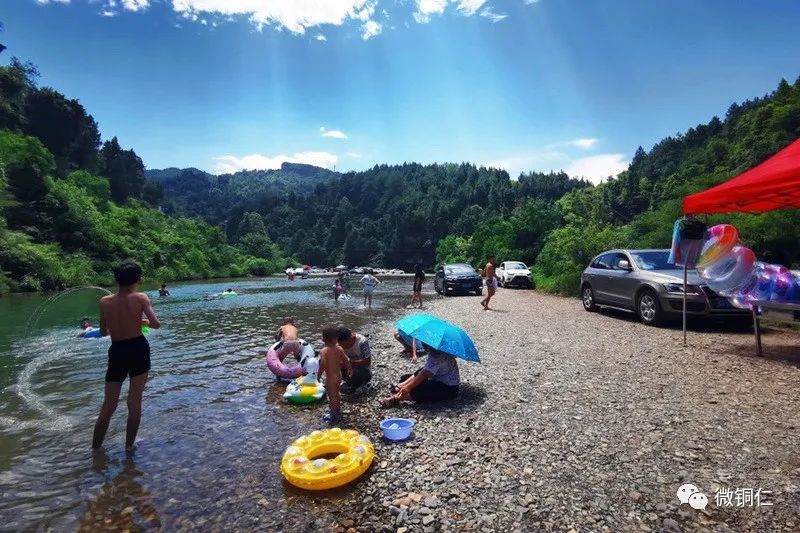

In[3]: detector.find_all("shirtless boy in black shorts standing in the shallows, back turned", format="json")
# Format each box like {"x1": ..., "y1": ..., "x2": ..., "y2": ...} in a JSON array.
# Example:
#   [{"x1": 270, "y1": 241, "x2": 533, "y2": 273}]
[{"x1": 92, "y1": 261, "x2": 161, "y2": 451}]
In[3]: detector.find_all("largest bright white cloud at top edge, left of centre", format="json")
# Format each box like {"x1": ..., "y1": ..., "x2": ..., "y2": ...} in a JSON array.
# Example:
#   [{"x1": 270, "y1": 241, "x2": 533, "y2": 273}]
[{"x1": 172, "y1": 0, "x2": 378, "y2": 34}]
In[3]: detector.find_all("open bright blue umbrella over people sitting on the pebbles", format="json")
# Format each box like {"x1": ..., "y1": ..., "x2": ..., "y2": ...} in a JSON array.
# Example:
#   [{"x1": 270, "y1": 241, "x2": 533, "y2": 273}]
[{"x1": 395, "y1": 313, "x2": 481, "y2": 363}]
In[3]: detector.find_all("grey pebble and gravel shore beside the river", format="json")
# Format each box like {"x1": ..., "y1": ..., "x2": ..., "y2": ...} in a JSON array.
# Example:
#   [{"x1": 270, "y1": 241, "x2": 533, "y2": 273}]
[{"x1": 287, "y1": 289, "x2": 800, "y2": 533}]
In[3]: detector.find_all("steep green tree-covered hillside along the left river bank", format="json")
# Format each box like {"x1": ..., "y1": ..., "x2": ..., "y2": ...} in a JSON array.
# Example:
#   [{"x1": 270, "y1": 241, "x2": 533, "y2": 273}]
[{"x1": 0, "y1": 50, "x2": 286, "y2": 293}]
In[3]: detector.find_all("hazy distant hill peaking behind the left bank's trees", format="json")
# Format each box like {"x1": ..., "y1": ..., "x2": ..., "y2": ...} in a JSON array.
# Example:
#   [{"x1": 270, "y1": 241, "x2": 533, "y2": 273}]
[{"x1": 145, "y1": 163, "x2": 340, "y2": 223}]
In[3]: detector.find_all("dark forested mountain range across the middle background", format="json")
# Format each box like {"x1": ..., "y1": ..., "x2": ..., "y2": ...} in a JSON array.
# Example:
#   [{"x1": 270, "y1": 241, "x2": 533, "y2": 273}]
[{"x1": 156, "y1": 163, "x2": 589, "y2": 268}]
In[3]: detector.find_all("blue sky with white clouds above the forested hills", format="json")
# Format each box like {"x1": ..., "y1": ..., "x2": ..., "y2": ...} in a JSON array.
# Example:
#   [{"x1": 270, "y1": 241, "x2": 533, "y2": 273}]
[{"x1": 0, "y1": 0, "x2": 800, "y2": 182}]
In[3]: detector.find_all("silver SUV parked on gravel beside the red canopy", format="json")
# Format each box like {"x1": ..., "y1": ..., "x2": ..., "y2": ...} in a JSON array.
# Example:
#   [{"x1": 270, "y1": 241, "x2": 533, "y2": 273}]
[{"x1": 581, "y1": 250, "x2": 747, "y2": 325}]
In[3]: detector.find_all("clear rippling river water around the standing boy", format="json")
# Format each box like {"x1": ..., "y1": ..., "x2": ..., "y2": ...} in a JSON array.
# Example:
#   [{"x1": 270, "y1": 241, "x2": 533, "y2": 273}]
[{"x1": 0, "y1": 278, "x2": 410, "y2": 530}]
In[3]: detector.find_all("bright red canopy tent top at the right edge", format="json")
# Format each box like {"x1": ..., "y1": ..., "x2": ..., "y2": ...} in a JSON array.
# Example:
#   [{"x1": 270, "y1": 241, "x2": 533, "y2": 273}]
[{"x1": 683, "y1": 139, "x2": 800, "y2": 215}]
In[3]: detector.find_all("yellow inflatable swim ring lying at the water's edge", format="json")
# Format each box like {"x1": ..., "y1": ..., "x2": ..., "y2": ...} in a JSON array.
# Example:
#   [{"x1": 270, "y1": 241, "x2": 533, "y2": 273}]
[{"x1": 281, "y1": 428, "x2": 375, "y2": 490}]
